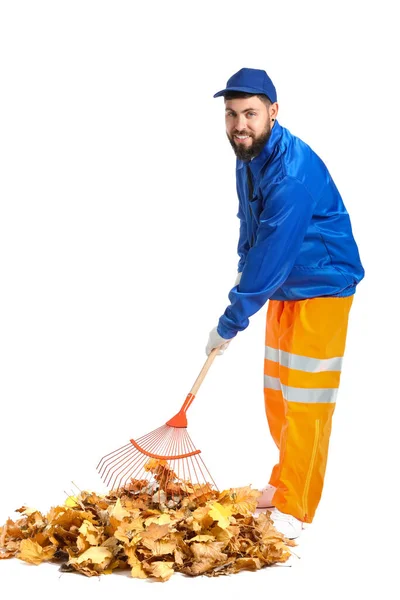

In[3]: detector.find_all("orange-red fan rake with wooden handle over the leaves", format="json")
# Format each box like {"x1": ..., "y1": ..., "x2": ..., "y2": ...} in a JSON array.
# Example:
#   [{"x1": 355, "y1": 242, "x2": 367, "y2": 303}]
[{"x1": 96, "y1": 348, "x2": 219, "y2": 501}]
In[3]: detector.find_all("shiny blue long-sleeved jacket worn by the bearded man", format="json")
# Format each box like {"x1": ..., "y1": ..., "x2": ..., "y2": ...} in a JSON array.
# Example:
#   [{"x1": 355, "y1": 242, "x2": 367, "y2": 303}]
[{"x1": 218, "y1": 121, "x2": 364, "y2": 339}]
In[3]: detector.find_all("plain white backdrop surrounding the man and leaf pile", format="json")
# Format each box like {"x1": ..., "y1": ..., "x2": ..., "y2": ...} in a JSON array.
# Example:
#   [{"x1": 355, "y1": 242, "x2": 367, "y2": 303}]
[{"x1": 0, "y1": 0, "x2": 400, "y2": 599}]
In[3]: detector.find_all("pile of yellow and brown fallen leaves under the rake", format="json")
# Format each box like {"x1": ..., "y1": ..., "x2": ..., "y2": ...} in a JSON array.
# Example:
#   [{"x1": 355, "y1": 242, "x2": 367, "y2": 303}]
[{"x1": 0, "y1": 460, "x2": 295, "y2": 581}]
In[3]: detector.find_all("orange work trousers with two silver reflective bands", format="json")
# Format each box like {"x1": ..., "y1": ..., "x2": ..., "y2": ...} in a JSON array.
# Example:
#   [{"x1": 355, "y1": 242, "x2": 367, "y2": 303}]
[{"x1": 264, "y1": 295, "x2": 354, "y2": 523}]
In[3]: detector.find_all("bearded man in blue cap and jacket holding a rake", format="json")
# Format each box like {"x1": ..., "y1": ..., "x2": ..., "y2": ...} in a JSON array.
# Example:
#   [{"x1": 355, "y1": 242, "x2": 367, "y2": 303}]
[{"x1": 206, "y1": 68, "x2": 364, "y2": 538}]
